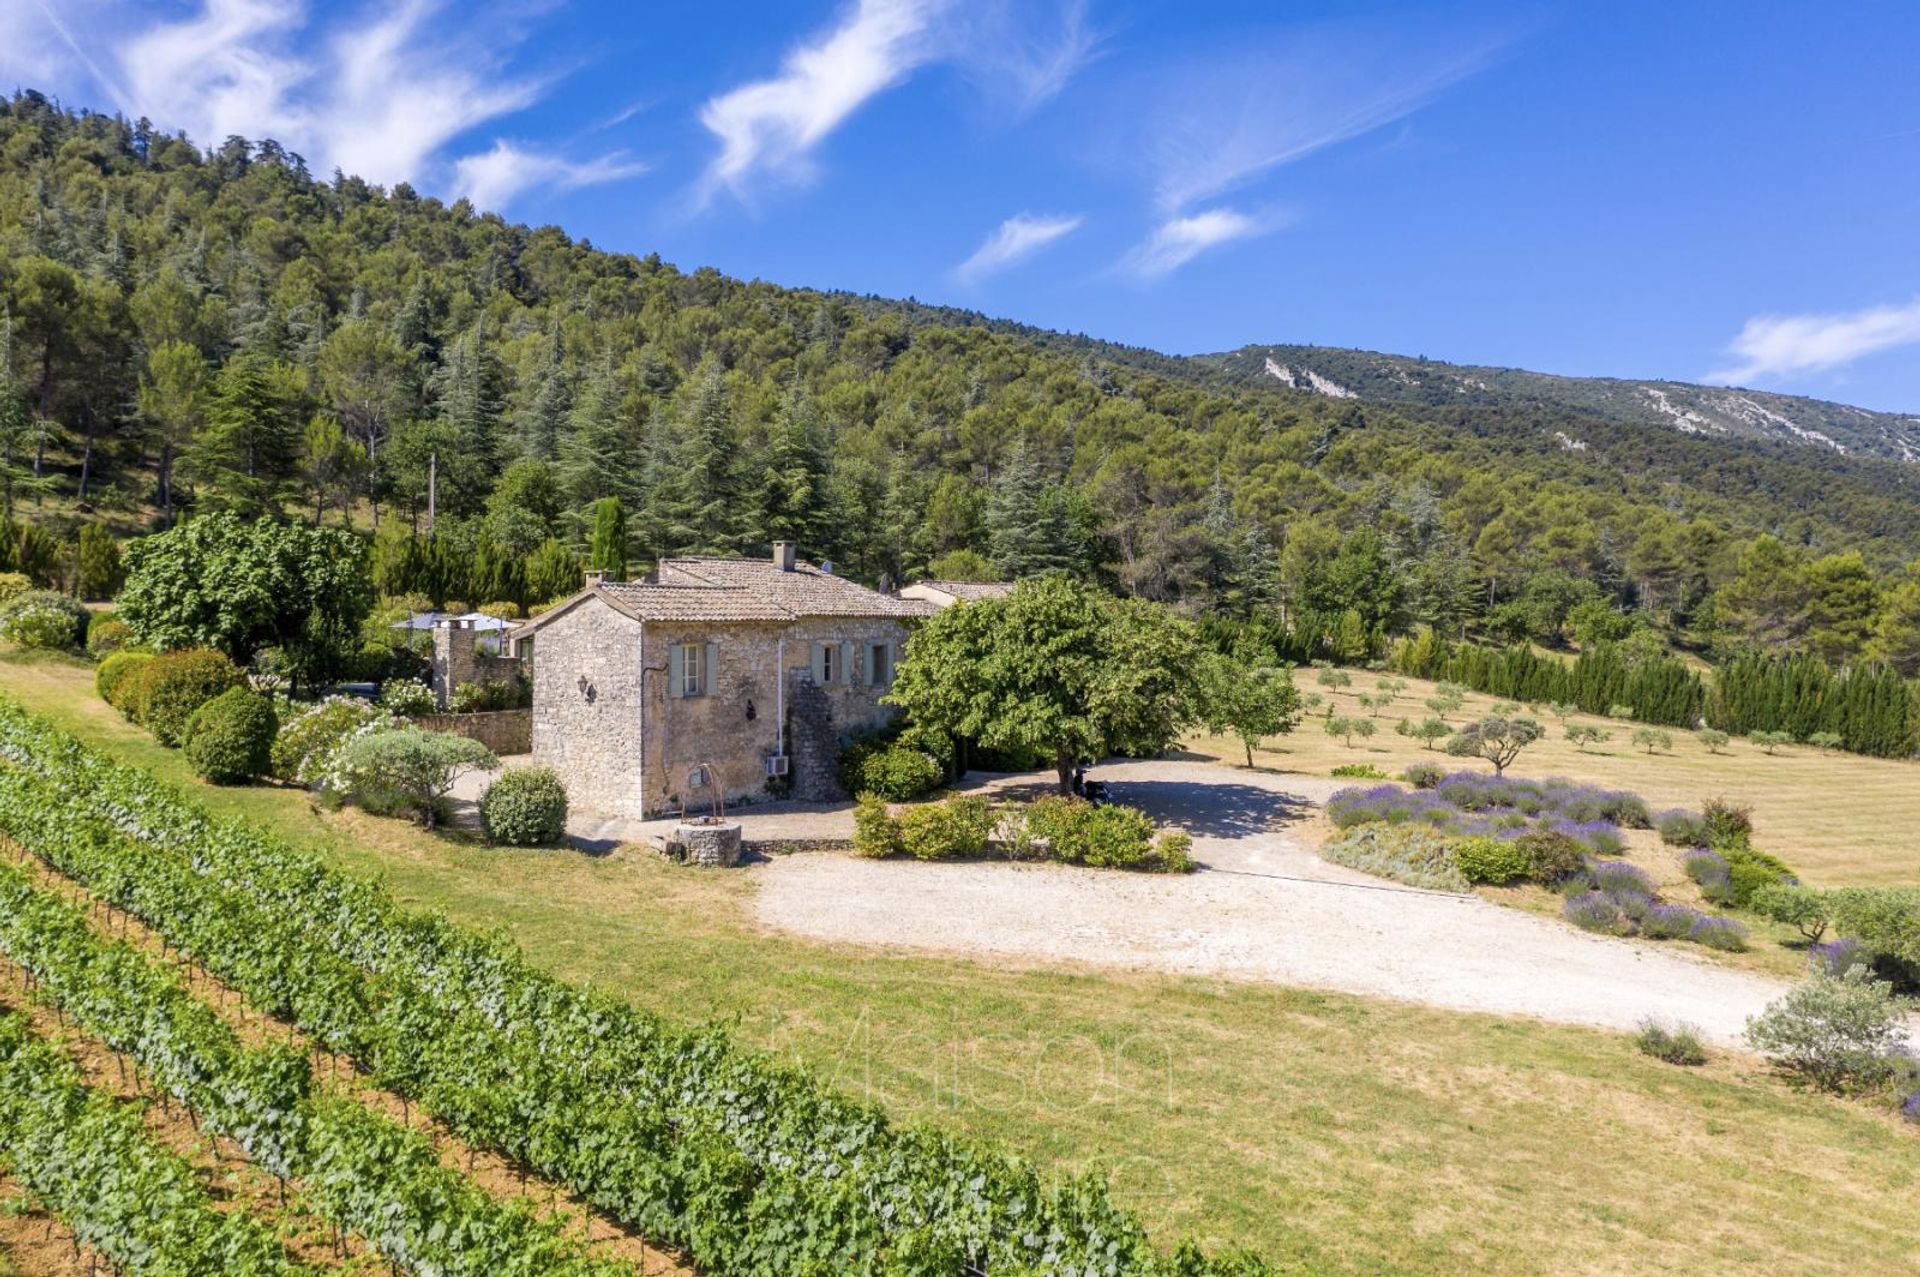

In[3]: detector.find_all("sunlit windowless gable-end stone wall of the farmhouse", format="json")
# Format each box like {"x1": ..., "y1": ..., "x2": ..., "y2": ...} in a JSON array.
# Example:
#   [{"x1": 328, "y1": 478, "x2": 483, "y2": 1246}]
[{"x1": 532, "y1": 595, "x2": 653, "y2": 816}]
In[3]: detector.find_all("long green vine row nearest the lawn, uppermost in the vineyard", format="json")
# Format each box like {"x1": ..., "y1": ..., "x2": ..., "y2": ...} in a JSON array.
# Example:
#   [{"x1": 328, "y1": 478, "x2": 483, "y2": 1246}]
[{"x1": 0, "y1": 701, "x2": 1267, "y2": 1277}]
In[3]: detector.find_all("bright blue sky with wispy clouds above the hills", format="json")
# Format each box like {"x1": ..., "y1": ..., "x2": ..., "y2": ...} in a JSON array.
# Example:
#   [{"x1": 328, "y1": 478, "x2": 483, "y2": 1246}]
[{"x1": 0, "y1": 0, "x2": 1920, "y2": 411}]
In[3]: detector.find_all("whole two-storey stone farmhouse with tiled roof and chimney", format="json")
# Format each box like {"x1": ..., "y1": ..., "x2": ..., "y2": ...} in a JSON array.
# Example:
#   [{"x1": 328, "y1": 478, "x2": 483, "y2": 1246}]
[{"x1": 513, "y1": 542, "x2": 937, "y2": 816}]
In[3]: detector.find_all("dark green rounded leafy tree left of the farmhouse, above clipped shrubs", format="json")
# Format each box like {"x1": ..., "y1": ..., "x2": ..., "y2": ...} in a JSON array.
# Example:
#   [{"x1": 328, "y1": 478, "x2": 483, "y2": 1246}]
[{"x1": 119, "y1": 515, "x2": 372, "y2": 686}]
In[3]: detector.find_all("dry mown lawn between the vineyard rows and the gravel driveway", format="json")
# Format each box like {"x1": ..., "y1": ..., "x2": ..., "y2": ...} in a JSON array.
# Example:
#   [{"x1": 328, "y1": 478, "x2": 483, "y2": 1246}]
[{"x1": 11, "y1": 663, "x2": 1920, "y2": 1273}]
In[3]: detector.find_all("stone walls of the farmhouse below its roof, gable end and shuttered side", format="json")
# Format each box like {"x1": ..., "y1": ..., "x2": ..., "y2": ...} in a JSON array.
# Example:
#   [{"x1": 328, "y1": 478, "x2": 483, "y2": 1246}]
[{"x1": 522, "y1": 591, "x2": 906, "y2": 816}]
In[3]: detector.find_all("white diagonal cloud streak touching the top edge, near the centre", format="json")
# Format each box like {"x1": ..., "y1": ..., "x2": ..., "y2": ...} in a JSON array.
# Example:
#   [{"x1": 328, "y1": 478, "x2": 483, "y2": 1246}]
[{"x1": 701, "y1": 0, "x2": 947, "y2": 194}]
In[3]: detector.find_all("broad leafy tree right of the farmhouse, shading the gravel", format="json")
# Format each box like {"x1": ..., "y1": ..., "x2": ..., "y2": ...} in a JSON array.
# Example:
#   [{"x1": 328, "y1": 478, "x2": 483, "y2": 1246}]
[{"x1": 889, "y1": 574, "x2": 1202, "y2": 791}]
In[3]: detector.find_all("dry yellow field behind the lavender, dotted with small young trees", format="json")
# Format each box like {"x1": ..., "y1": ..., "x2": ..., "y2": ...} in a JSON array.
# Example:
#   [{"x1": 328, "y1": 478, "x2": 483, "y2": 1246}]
[{"x1": 1188, "y1": 670, "x2": 1920, "y2": 887}]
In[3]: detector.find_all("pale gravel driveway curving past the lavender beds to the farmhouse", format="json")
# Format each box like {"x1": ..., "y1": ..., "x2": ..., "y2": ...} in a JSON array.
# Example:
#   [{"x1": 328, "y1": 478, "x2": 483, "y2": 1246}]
[{"x1": 741, "y1": 760, "x2": 1784, "y2": 1045}]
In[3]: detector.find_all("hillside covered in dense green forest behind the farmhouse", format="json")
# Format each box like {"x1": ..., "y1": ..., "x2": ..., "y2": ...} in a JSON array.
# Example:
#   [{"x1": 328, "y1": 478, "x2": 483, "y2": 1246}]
[{"x1": 11, "y1": 92, "x2": 1920, "y2": 672}]
